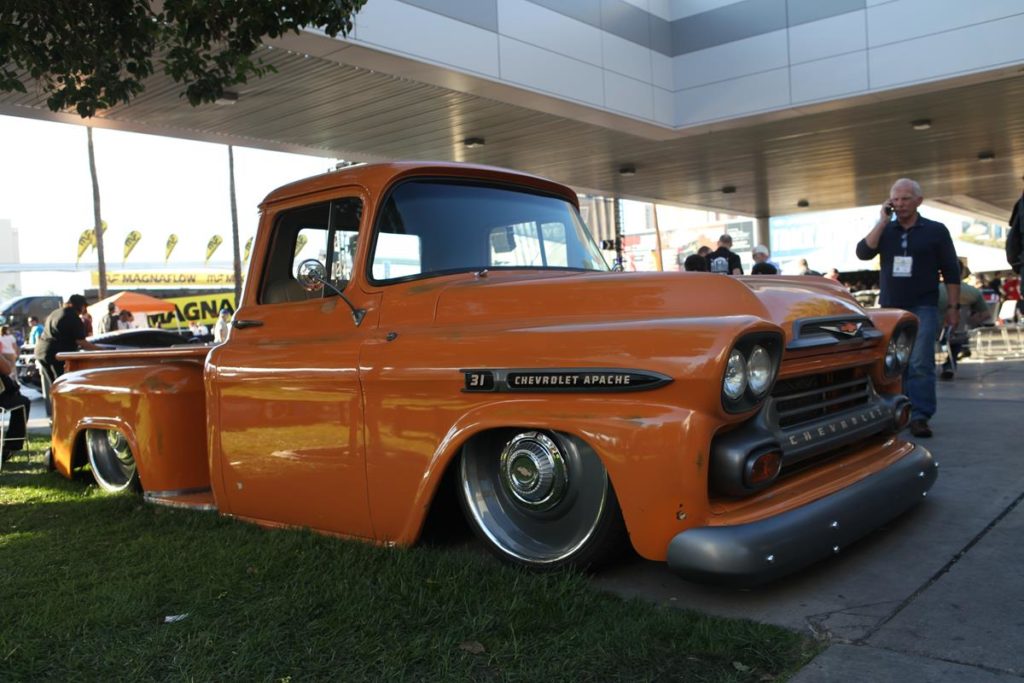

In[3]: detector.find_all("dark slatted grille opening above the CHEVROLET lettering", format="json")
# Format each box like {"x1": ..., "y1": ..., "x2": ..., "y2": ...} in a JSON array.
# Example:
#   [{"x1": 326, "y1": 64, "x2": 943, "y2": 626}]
[{"x1": 771, "y1": 367, "x2": 872, "y2": 429}]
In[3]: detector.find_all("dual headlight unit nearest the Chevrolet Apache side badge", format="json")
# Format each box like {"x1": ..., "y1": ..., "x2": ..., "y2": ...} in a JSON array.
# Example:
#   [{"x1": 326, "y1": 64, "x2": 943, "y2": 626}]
[{"x1": 719, "y1": 332, "x2": 782, "y2": 413}]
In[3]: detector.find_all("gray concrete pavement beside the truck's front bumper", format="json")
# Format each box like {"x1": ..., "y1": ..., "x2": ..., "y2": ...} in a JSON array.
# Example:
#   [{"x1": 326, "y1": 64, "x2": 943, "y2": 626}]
[{"x1": 595, "y1": 360, "x2": 1024, "y2": 683}]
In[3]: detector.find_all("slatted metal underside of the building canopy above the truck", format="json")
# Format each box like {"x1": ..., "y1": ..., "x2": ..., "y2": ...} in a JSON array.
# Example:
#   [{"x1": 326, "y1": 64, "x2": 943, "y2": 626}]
[{"x1": 0, "y1": 43, "x2": 1024, "y2": 216}]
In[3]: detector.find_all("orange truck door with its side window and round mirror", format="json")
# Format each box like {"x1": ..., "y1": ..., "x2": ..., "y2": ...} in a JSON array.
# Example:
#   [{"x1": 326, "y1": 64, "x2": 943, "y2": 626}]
[{"x1": 207, "y1": 196, "x2": 373, "y2": 538}]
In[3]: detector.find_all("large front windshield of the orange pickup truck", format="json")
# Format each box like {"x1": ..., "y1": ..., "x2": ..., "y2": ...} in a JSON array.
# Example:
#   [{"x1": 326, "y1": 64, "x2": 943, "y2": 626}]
[{"x1": 371, "y1": 180, "x2": 608, "y2": 283}]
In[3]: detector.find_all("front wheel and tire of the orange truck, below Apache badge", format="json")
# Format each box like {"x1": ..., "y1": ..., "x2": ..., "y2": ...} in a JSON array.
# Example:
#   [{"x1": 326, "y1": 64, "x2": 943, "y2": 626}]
[{"x1": 458, "y1": 430, "x2": 627, "y2": 569}]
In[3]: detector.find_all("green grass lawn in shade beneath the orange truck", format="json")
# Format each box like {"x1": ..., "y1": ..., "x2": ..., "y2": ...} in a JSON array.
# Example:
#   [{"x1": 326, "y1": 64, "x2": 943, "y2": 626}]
[{"x1": 0, "y1": 438, "x2": 818, "y2": 682}]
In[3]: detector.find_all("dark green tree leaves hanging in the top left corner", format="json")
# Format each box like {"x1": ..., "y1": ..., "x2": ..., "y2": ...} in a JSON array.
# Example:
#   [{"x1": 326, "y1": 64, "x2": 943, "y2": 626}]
[{"x1": 0, "y1": 0, "x2": 367, "y2": 118}]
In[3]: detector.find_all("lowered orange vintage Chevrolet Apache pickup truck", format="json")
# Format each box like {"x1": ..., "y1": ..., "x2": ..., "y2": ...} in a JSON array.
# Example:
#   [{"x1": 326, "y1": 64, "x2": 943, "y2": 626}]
[{"x1": 52, "y1": 163, "x2": 936, "y2": 583}]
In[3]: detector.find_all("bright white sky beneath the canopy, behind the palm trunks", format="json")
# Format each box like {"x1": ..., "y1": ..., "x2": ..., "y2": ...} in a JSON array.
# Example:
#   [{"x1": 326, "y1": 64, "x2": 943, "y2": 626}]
[{"x1": 0, "y1": 116, "x2": 336, "y2": 296}]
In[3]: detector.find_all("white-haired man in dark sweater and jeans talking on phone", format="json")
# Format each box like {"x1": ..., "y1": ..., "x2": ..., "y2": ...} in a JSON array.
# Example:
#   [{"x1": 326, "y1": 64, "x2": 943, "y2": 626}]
[{"x1": 857, "y1": 178, "x2": 959, "y2": 437}]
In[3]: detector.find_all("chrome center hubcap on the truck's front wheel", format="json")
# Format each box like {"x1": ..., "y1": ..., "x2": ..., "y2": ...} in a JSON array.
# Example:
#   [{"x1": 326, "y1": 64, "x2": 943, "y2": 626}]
[{"x1": 501, "y1": 432, "x2": 568, "y2": 510}]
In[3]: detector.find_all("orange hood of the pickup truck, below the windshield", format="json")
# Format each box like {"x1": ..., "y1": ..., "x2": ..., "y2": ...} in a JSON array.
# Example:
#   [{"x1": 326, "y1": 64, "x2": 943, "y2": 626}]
[{"x1": 430, "y1": 272, "x2": 865, "y2": 341}]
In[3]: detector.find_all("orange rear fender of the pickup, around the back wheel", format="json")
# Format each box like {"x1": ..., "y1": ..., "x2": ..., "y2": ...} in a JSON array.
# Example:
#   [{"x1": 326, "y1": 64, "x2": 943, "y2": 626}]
[{"x1": 51, "y1": 360, "x2": 210, "y2": 492}]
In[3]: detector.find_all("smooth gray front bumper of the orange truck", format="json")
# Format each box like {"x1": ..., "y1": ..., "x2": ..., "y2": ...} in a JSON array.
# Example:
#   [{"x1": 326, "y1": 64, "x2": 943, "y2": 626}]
[{"x1": 668, "y1": 445, "x2": 938, "y2": 585}]
